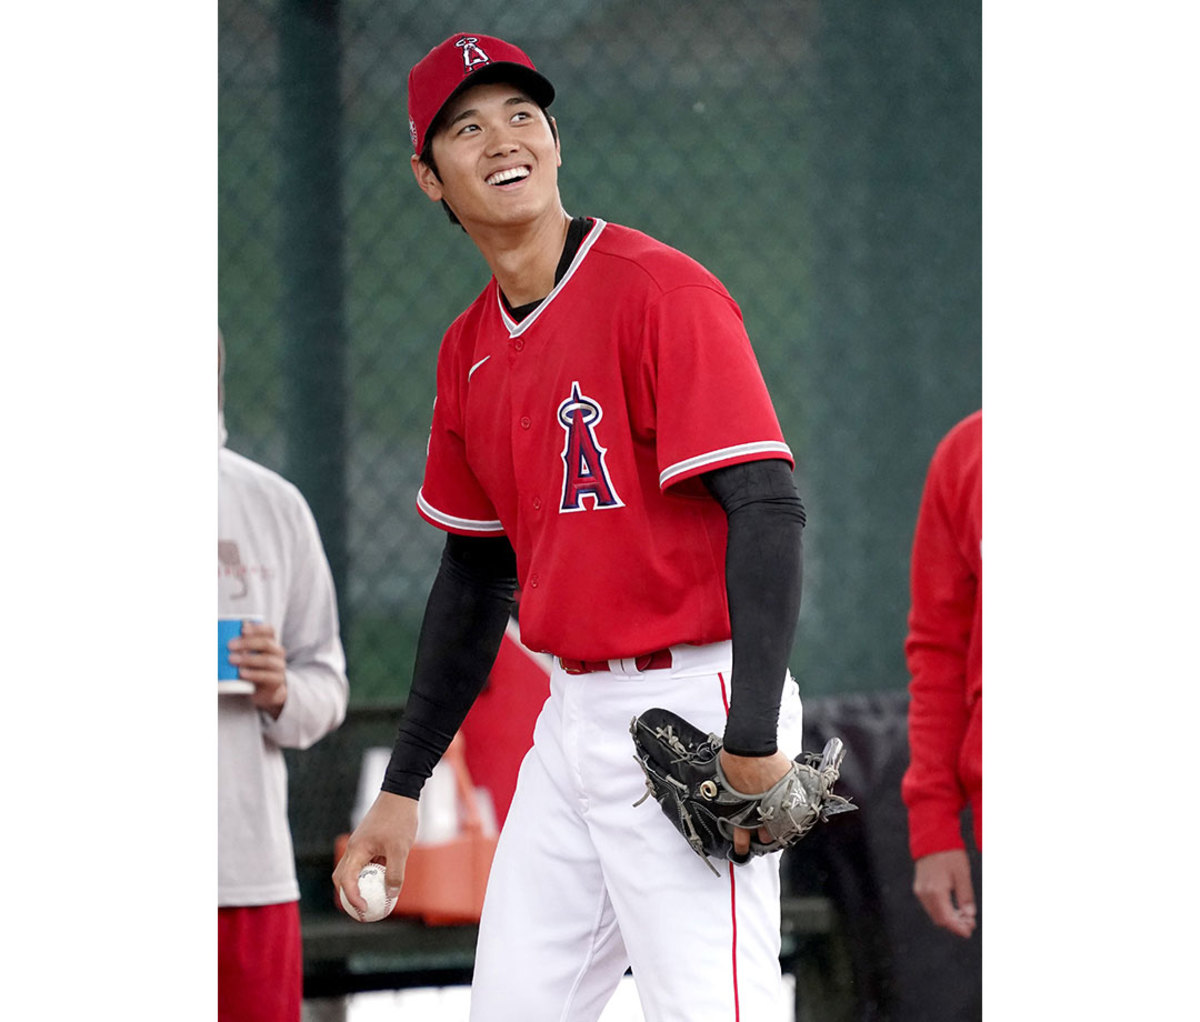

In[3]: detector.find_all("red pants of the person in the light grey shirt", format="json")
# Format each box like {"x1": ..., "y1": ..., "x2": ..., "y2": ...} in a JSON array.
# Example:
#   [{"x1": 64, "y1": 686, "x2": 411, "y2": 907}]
[{"x1": 217, "y1": 901, "x2": 304, "y2": 1022}]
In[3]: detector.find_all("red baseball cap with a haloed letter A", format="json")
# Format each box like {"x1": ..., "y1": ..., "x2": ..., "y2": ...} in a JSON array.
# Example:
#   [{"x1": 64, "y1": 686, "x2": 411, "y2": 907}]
[{"x1": 408, "y1": 32, "x2": 554, "y2": 154}]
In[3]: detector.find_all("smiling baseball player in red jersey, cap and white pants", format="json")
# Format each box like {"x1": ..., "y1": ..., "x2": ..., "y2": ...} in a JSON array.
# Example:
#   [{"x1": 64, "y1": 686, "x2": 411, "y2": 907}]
[{"x1": 334, "y1": 34, "x2": 804, "y2": 1022}]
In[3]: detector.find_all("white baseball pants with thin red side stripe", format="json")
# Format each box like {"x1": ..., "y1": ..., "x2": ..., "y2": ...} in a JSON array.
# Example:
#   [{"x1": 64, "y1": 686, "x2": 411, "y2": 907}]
[{"x1": 470, "y1": 642, "x2": 802, "y2": 1022}]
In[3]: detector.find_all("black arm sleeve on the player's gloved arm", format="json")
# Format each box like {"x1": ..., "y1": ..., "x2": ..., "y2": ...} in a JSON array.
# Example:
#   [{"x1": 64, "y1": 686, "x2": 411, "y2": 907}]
[{"x1": 702, "y1": 459, "x2": 805, "y2": 756}]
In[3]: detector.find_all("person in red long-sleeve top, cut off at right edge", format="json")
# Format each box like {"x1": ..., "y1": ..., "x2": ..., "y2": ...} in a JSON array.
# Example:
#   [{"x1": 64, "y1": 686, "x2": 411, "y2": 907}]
[{"x1": 901, "y1": 410, "x2": 983, "y2": 937}]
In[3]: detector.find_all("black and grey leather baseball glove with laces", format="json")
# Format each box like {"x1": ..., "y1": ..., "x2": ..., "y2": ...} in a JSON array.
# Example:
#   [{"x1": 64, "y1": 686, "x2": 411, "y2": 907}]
[{"x1": 629, "y1": 708, "x2": 858, "y2": 874}]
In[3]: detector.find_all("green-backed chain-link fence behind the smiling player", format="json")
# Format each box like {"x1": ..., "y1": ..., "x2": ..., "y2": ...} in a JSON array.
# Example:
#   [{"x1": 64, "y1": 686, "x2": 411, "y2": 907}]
[{"x1": 218, "y1": 0, "x2": 982, "y2": 704}]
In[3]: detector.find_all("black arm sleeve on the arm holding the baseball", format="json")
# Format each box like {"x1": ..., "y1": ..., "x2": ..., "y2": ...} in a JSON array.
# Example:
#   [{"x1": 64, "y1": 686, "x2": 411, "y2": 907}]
[{"x1": 383, "y1": 535, "x2": 517, "y2": 799}]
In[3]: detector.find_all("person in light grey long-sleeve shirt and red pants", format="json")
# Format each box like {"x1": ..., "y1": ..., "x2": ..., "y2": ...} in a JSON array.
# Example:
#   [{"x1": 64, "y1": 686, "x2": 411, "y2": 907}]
[{"x1": 217, "y1": 331, "x2": 349, "y2": 1022}]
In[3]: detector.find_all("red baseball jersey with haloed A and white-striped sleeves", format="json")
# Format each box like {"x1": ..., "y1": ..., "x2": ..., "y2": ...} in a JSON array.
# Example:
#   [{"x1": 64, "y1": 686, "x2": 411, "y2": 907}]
[{"x1": 418, "y1": 220, "x2": 794, "y2": 660}]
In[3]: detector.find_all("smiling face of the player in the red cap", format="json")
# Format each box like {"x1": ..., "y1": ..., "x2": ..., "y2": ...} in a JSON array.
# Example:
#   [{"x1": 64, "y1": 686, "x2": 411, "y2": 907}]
[{"x1": 413, "y1": 83, "x2": 562, "y2": 233}]
